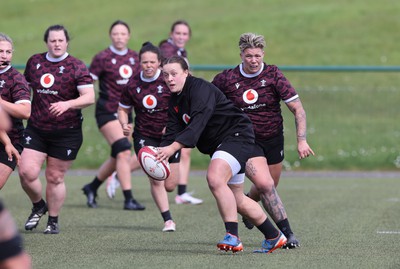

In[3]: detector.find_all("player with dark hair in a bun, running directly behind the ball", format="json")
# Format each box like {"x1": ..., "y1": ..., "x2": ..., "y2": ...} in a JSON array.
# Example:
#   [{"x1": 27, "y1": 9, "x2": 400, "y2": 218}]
[{"x1": 118, "y1": 42, "x2": 180, "y2": 232}]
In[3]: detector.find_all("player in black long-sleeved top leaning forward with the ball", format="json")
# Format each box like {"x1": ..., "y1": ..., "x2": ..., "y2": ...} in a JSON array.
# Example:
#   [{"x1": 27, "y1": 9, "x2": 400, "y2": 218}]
[{"x1": 158, "y1": 56, "x2": 286, "y2": 253}]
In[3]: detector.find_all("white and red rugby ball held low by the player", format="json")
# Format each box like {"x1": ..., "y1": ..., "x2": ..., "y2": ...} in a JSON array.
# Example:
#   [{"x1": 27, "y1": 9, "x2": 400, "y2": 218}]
[{"x1": 138, "y1": 146, "x2": 171, "y2": 181}]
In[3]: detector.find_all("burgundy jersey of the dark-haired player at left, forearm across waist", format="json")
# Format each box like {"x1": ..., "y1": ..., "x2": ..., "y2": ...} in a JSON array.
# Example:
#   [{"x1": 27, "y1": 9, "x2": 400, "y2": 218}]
[{"x1": 24, "y1": 53, "x2": 93, "y2": 131}]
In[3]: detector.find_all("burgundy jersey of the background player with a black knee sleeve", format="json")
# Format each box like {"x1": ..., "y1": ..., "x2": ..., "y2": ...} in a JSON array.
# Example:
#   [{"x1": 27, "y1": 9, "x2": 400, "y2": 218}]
[{"x1": 89, "y1": 46, "x2": 140, "y2": 113}]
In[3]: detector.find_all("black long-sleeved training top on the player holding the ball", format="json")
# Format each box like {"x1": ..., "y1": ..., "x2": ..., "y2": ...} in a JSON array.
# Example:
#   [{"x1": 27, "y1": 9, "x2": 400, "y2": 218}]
[{"x1": 161, "y1": 76, "x2": 254, "y2": 154}]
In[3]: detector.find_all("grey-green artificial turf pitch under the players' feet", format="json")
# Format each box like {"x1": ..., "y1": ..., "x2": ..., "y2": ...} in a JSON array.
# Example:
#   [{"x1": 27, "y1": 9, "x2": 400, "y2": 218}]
[{"x1": 2, "y1": 171, "x2": 400, "y2": 269}]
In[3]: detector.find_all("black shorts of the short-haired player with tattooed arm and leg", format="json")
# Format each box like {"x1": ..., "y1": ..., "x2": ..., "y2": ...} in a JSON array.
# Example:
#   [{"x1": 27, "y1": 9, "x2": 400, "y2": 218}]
[{"x1": 252, "y1": 134, "x2": 285, "y2": 164}]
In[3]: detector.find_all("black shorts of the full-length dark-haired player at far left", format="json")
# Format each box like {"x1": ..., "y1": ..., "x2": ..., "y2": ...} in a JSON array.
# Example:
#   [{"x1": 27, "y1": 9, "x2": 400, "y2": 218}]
[{"x1": 23, "y1": 126, "x2": 83, "y2": 161}]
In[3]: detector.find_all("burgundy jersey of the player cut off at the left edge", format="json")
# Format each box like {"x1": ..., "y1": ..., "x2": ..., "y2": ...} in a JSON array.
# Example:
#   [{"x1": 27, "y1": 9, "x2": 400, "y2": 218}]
[{"x1": 0, "y1": 65, "x2": 31, "y2": 144}]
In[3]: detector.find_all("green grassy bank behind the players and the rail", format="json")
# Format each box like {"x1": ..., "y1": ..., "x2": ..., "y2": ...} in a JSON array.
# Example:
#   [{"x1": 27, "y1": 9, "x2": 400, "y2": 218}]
[{"x1": 0, "y1": 0, "x2": 400, "y2": 171}]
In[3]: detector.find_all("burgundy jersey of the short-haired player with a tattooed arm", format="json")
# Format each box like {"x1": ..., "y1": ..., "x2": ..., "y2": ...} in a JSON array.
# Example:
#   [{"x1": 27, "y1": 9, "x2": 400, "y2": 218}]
[{"x1": 212, "y1": 63, "x2": 298, "y2": 139}]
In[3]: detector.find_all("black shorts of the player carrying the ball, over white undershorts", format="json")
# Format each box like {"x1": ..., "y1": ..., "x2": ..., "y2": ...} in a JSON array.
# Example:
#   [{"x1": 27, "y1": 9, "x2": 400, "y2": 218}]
[{"x1": 211, "y1": 137, "x2": 255, "y2": 174}]
